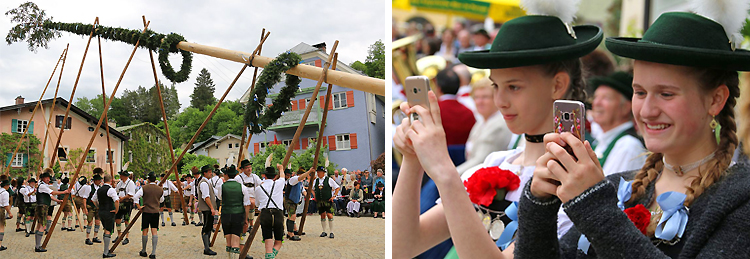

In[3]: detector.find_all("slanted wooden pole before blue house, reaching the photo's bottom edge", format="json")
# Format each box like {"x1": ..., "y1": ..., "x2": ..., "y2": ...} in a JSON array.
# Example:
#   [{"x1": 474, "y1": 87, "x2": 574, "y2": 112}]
[{"x1": 239, "y1": 40, "x2": 339, "y2": 259}]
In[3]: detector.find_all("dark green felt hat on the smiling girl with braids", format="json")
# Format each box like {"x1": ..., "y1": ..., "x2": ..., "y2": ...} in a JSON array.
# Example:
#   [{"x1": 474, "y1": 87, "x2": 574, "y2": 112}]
[{"x1": 605, "y1": 12, "x2": 750, "y2": 71}]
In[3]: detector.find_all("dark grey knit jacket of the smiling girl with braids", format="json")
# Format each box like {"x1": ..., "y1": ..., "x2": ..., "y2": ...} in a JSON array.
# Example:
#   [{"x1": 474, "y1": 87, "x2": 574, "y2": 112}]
[{"x1": 514, "y1": 164, "x2": 750, "y2": 259}]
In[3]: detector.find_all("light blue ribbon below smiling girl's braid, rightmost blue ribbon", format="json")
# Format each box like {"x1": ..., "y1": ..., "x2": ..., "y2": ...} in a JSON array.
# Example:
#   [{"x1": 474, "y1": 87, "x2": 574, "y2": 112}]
[{"x1": 654, "y1": 192, "x2": 688, "y2": 243}]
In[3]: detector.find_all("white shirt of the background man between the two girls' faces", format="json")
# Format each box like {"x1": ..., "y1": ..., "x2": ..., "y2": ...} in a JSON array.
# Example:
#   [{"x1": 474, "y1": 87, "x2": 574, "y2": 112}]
[{"x1": 594, "y1": 121, "x2": 646, "y2": 176}]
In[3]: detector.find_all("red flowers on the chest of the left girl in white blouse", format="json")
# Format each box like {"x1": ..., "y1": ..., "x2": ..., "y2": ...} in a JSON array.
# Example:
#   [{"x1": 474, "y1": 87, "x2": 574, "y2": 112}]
[{"x1": 464, "y1": 166, "x2": 521, "y2": 206}]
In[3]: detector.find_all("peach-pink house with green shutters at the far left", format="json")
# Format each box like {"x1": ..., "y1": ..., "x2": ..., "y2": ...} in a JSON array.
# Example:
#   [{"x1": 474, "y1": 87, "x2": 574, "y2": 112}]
[{"x1": 0, "y1": 96, "x2": 128, "y2": 176}]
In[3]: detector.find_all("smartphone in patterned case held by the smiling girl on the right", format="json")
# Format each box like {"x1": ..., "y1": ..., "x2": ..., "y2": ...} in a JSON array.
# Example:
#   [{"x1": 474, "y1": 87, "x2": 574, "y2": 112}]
[{"x1": 552, "y1": 100, "x2": 586, "y2": 155}]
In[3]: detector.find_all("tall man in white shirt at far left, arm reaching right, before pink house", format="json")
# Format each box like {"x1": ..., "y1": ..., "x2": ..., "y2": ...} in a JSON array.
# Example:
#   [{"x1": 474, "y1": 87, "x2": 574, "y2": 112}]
[{"x1": 34, "y1": 168, "x2": 70, "y2": 252}]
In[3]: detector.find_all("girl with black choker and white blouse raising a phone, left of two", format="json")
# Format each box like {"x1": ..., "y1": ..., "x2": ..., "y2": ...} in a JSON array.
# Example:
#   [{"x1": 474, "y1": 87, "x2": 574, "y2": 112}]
[{"x1": 393, "y1": 1, "x2": 602, "y2": 258}]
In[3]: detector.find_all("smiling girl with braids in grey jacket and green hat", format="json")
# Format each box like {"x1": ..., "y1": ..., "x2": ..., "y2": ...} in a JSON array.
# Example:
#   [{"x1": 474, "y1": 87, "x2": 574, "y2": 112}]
[{"x1": 515, "y1": 0, "x2": 750, "y2": 258}]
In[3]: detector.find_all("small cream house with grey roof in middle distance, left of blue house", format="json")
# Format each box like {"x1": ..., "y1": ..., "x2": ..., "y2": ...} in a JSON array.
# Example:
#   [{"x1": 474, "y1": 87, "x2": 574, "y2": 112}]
[{"x1": 188, "y1": 134, "x2": 249, "y2": 167}]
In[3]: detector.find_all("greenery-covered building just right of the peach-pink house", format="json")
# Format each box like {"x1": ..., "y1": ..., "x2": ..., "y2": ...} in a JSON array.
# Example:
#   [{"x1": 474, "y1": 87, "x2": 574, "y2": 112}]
[{"x1": 117, "y1": 122, "x2": 171, "y2": 176}]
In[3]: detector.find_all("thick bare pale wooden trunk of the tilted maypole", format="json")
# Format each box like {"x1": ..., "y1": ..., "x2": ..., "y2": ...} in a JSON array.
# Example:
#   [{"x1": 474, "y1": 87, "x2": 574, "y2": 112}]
[{"x1": 177, "y1": 41, "x2": 385, "y2": 96}]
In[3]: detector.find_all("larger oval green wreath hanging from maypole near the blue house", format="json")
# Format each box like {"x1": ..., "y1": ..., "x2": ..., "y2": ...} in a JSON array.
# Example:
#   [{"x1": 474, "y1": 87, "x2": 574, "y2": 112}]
[{"x1": 245, "y1": 51, "x2": 302, "y2": 134}]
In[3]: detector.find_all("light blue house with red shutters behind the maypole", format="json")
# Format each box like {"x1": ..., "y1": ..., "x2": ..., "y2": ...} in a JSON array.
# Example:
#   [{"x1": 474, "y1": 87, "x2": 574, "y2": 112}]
[{"x1": 240, "y1": 42, "x2": 385, "y2": 170}]
